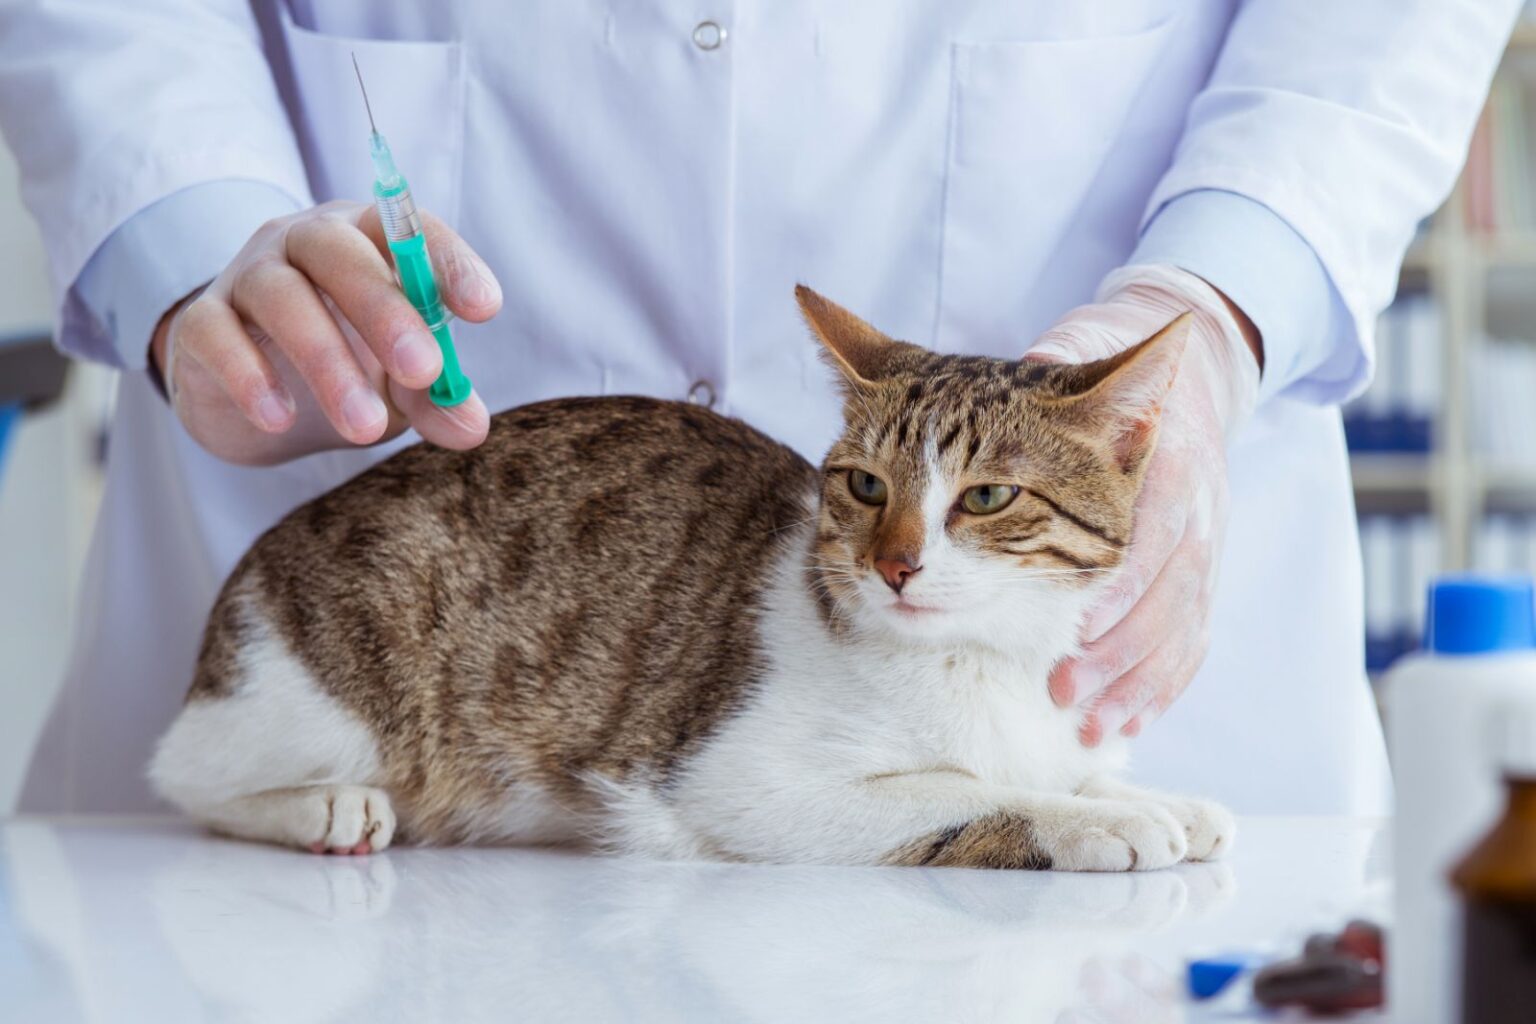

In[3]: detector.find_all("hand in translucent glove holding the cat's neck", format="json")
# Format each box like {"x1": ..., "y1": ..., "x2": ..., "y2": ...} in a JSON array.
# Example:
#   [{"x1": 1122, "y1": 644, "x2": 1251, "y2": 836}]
[{"x1": 1028, "y1": 266, "x2": 1263, "y2": 746}]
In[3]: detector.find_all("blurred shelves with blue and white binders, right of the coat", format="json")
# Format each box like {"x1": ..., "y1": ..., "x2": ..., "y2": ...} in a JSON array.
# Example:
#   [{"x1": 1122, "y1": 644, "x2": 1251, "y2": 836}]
[{"x1": 1344, "y1": 18, "x2": 1536, "y2": 676}]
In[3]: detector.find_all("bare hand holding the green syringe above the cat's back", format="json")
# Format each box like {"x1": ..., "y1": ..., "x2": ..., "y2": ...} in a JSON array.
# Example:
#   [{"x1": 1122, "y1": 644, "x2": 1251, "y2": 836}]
[{"x1": 151, "y1": 201, "x2": 501, "y2": 465}]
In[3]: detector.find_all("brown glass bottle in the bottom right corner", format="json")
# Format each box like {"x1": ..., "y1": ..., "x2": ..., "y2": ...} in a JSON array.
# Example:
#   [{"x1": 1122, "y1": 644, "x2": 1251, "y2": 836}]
[{"x1": 1452, "y1": 772, "x2": 1536, "y2": 1024}]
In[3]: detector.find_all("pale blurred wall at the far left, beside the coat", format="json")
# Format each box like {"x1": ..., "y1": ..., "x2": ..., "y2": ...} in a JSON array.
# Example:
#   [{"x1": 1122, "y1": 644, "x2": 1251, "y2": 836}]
[{"x1": 0, "y1": 144, "x2": 111, "y2": 814}]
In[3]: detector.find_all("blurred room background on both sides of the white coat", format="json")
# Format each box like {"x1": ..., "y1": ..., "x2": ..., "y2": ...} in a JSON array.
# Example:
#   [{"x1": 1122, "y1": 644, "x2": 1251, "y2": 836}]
[{"x1": 9, "y1": 11, "x2": 1536, "y2": 814}]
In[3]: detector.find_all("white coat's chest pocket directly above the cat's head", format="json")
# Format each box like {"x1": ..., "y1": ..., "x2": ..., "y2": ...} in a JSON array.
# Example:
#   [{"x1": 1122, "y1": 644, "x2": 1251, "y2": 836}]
[{"x1": 935, "y1": 18, "x2": 1175, "y2": 355}]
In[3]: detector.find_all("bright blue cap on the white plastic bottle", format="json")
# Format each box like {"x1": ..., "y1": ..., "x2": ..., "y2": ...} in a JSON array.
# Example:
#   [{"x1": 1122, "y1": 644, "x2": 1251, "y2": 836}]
[{"x1": 1424, "y1": 574, "x2": 1536, "y2": 654}]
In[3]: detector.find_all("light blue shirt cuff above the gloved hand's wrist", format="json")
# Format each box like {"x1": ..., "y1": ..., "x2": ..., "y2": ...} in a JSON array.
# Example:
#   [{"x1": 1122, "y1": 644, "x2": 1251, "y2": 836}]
[{"x1": 1127, "y1": 189, "x2": 1372, "y2": 404}]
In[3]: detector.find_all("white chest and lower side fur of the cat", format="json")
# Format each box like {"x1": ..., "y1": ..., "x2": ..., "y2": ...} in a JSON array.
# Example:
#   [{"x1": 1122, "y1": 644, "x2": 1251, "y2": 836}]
[{"x1": 709, "y1": 577, "x2": 1124, "y2": 810}]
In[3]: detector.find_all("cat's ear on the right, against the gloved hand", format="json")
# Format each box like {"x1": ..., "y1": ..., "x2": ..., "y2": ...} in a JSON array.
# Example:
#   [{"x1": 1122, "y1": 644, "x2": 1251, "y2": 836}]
[{"x1": 1054, "y1": 313, "x2": 1193, "y2": 471}]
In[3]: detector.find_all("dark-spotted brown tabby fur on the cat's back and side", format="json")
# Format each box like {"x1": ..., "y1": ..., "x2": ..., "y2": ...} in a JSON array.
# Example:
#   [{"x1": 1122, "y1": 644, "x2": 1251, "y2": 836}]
[{"x1": 190, "y1": 398, "x2": 816, "y2": 841}]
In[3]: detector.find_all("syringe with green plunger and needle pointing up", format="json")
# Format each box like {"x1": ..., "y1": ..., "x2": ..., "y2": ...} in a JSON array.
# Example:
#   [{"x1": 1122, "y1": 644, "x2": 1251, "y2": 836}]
[{"x1": 352, "y1": 54, "x2": 472, "y2": 405}]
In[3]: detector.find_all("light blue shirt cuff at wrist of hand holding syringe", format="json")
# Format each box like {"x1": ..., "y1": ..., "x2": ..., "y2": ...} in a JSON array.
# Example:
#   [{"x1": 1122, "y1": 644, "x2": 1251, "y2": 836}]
[{"x1": 58, "y1": 180, "x2": 301, "y2": 370}]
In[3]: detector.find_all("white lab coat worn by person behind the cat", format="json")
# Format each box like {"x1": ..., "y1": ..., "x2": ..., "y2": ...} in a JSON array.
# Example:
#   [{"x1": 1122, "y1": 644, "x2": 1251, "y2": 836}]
[{"x1": 6, "y1": 0, "x2": 1516, "y2": 812}]
